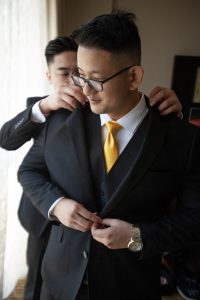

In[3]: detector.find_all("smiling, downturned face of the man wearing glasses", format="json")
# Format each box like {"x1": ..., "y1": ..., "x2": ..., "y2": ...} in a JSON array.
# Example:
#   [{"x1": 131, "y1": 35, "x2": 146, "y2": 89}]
[{"x1": 77, "y1": 46, "x2": 141, "y2": 120}]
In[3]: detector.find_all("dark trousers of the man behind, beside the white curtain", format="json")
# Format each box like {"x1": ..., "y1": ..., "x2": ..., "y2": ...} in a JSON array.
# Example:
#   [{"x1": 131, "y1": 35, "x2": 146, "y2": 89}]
[{"x1": 24, "y1": 226, "x2": 50, "y2": 300}]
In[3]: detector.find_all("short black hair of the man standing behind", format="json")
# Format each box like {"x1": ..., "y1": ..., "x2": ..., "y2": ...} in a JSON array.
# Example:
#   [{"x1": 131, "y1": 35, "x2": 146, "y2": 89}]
[{"x1": 45, "y1": 35, "x2": 78, "y2": 65}]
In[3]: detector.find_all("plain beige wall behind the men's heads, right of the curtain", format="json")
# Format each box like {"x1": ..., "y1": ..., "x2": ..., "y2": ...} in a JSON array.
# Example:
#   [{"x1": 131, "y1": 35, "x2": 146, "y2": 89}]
[{"x1": 57, "y1": 0, "x2": 200, "y2": 93}]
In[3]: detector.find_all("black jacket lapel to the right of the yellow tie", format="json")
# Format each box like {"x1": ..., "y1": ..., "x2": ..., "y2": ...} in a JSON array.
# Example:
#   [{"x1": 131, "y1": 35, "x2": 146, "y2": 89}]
[{"x1": 101, "y1": 108, "x2": 166, "y2": 217}]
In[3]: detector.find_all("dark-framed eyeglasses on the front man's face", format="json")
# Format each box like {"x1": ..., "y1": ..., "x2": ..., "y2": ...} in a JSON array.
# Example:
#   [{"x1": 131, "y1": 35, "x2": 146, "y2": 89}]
[{"x1": 71, "y1": 65, "x2": 135, "y2": 92}]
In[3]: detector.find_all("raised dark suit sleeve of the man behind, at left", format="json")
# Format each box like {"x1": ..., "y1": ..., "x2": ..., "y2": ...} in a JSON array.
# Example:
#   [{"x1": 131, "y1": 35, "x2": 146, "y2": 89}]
[{"x1": 0, "y1": 97, "x2": 44, "y2": 150}]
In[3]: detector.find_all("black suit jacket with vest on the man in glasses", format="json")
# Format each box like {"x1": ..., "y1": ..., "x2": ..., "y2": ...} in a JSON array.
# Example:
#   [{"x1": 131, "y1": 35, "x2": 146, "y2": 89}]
[{"x1": 18, "y1": 99, "x2": 200, "y2": 300}]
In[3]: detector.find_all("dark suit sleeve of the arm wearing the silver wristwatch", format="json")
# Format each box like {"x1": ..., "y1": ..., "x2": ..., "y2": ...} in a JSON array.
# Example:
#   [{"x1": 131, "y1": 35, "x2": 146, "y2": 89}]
[{"x1": 140, "y1": 131, "x2": 200, "y2": 259}]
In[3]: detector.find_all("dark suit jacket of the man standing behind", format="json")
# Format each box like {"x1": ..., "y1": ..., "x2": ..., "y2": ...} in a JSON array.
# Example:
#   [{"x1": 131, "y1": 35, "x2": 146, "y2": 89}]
[{"x1": 0, "y1": 97, "x2": 49, "y2": 238}]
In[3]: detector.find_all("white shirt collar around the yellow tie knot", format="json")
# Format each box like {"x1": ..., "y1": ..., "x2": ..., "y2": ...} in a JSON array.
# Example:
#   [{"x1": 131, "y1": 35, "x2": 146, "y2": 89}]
[{"x1": 100, "y1": 94, "x2": 147, "y2": 133}]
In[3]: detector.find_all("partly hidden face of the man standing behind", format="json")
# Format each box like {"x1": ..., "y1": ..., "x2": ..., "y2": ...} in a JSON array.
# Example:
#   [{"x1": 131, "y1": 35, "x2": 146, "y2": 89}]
[{"x1": 47, "y1": 51, "x2": 77, "y2": 89}]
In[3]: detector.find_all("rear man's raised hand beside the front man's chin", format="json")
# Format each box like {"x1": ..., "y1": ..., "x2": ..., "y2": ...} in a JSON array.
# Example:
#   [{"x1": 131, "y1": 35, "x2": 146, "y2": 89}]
[{"x1": 39, "y1": 83, "x2": 87, "y2": 114}]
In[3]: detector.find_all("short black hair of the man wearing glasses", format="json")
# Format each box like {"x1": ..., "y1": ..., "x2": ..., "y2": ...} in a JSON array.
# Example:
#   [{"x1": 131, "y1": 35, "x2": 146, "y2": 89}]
[{"x1": 76, "y1": 10, "x2": 141, "y2": 64}]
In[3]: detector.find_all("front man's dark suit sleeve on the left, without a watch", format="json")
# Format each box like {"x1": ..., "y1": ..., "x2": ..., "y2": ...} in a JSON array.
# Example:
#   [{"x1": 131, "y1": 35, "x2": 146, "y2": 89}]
[{"x1": 18, "y1": 123, "x2": 65, "y2": 218}]
